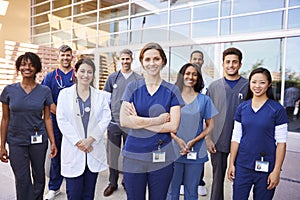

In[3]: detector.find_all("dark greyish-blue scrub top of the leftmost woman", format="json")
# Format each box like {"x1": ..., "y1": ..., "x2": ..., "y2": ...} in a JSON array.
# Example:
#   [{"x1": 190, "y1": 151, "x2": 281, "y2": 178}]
[{"x1": 0, "y1": 83, "x2": 53, "y2": 146}]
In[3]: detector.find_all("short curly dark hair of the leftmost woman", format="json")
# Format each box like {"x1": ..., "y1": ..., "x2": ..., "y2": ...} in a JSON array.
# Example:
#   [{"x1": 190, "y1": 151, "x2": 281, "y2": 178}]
[{"x1": 15, "y1": 52, "x2": 42, "y2": 78}]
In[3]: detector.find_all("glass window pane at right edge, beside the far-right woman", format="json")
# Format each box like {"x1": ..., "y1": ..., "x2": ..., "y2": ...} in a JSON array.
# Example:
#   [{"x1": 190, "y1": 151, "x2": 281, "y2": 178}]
[{"x1": 284, "y1": 37, "x2": 300, "y2": 132}]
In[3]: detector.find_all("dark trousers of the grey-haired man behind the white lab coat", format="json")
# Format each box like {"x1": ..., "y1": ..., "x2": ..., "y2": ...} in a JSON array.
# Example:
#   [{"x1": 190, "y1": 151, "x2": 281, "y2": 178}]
[{"x1": 107, "y1": 123, "x2": 127, "y2": 187}]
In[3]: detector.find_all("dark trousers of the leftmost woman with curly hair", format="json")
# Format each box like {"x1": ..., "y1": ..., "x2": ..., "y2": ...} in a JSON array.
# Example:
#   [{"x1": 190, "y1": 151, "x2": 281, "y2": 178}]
[{"x1": 9, "y1": 141, "x2": 48, "y2": 200}]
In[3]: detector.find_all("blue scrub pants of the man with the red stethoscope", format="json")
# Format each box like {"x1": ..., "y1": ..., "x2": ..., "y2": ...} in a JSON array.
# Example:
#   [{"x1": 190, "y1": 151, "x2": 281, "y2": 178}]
[{"x1": 48, "y1": 118, "x2": 64, "y2": 191}]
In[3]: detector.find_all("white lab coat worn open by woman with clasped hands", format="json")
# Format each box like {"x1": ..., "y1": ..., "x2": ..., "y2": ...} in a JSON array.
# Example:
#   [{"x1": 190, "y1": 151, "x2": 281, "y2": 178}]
[{"x1": 56, "y1": 85, "x2": 111, "y2": 178}]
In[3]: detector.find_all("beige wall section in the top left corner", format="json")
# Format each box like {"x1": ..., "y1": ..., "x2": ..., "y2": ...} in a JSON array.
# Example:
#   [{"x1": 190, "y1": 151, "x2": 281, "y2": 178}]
[{"x1": 0, "y1": 0, "x2": 30, "y2": 58}]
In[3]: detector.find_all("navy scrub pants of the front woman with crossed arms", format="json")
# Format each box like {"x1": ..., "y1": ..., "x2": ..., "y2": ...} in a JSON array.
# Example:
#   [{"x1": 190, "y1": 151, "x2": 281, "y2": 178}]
[{"x1": 123, "y1": 157, "x2": 173, "y2": 200}]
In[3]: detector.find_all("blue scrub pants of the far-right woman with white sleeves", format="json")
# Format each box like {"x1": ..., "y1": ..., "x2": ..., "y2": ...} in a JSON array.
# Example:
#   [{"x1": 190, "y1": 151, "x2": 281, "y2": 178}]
[{"x1": 233, "y1": 166, "x2": 275, "y2": 200}]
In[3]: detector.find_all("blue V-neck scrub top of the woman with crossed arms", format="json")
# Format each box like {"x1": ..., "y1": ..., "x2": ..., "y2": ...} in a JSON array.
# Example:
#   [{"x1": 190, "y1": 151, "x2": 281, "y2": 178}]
[{"x1": 121, "y1": 79, "x2": 184, "y2": 162}]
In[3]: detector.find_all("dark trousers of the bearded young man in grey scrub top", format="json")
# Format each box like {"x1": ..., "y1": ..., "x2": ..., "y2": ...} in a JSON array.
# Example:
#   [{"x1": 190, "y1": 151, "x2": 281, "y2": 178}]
[{"x1": 210, "y1": 151, "x2": 229, "y2": 200}]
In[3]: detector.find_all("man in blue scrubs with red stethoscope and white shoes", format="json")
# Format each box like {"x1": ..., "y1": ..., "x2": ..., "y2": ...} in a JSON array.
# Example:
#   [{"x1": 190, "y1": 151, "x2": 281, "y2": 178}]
[{"x1": 42, "y1": 45, "x2": 75, "y2": 199}]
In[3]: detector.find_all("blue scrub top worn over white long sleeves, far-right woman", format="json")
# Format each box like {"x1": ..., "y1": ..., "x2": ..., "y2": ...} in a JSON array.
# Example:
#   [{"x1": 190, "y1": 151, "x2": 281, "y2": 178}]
[{"x1": 234, "y1": 99, "x2": 289, "y2": 170}]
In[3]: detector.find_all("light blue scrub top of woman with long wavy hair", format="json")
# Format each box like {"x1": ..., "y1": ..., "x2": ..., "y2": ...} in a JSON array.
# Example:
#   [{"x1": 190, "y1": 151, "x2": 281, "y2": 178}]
[{"x1": 173, "y1": 93, "x2": 218, "y2": 164}]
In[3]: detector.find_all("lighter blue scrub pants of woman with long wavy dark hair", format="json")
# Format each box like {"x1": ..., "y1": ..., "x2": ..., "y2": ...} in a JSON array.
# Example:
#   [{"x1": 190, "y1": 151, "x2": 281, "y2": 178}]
[{"x1": 167, "y1": 162, "x2": 204, "y2": 200}]
